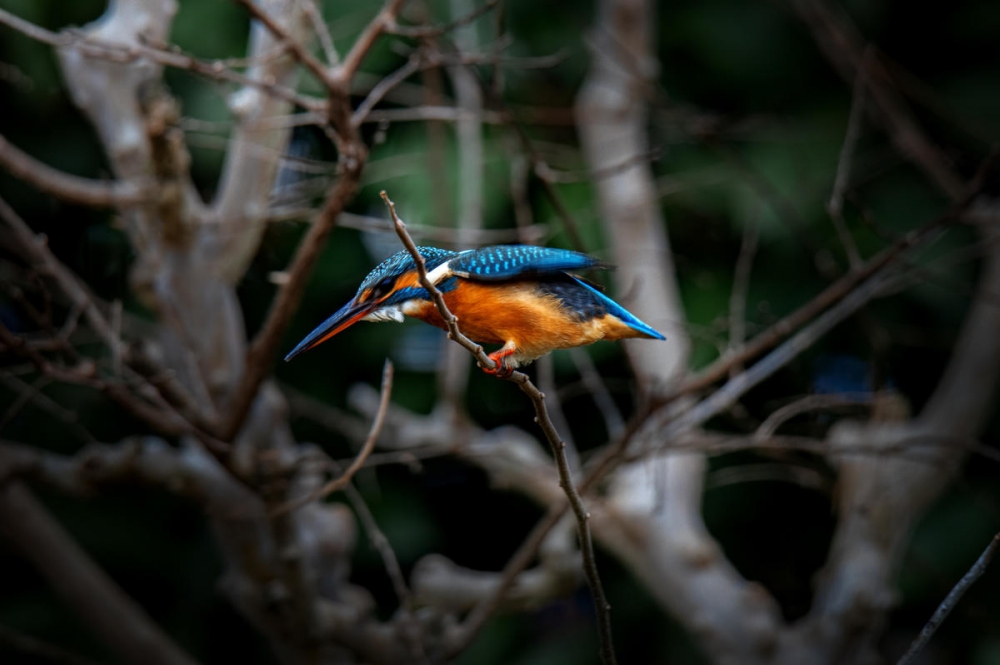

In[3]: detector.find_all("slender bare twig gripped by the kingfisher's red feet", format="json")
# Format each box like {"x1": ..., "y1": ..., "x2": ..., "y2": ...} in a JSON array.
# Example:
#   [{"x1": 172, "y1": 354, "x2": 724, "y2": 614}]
[{"x1": 381, "y1": 191, "x2": 617, "y2": 665}]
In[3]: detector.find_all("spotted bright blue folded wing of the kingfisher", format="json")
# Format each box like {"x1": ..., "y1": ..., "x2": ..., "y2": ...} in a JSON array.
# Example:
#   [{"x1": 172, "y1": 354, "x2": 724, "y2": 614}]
[{"x1": 448, "y1": 245, "x2": 604, "y2": 282}]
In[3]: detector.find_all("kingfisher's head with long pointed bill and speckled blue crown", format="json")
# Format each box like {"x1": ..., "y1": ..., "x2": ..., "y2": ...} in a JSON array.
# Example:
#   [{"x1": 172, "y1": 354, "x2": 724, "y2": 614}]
[{"x1": 285, "y1": 247, "x2": 456, "y2": 362}]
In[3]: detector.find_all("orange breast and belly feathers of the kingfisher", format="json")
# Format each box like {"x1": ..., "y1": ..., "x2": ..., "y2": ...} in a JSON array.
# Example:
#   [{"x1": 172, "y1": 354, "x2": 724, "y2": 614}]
[{"x1": 412, "y1": 278, "x2": 641, "y2": 357}]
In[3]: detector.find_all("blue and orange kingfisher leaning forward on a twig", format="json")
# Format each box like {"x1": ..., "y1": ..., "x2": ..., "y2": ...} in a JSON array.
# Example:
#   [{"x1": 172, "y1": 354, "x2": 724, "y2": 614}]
[{"x1": 285, "y1": 245, "x2": 666, "y2": 376}]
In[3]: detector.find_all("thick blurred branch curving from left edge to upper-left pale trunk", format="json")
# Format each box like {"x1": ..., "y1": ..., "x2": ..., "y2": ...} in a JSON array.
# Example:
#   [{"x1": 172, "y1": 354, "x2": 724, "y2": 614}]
[{"x1": 0, "y1": 136, "x2": 149, "y2": 208}]
